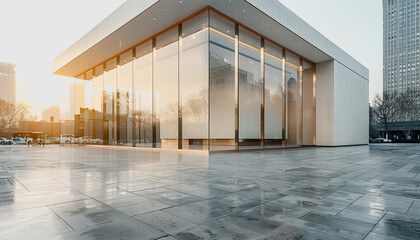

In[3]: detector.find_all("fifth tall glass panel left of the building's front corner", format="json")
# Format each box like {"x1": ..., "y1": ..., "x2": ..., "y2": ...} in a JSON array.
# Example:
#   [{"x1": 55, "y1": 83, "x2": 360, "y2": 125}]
[{"x1": 103, "y1": 59, "x2": 117, "y2": 145}]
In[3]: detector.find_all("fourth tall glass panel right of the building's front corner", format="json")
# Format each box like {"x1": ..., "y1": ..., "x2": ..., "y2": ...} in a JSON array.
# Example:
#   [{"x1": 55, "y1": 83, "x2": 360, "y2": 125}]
[{"x1": 286, "y1": 56, "x2": 302, "y2": 147}]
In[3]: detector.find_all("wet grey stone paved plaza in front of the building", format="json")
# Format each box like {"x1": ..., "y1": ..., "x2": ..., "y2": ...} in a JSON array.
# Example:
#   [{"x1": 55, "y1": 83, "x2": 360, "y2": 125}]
[{"x1": 0, "y1": 144, "x2": 420, "y2": 240}]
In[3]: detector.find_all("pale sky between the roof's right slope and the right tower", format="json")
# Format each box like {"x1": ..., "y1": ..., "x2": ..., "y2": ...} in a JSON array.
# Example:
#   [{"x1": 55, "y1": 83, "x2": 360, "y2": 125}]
[{"x1": 279, "y1": 0, "x2": 383, "y2": 102}]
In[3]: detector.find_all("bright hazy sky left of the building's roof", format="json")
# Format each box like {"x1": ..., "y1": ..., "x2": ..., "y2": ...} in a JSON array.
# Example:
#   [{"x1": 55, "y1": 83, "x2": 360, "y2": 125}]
[{"x1": 0, "y1": 0, "x2": 125, "y2": 117}]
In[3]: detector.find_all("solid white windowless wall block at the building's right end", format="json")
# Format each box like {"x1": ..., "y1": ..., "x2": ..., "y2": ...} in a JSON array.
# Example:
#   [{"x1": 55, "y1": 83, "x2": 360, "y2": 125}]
[{"x1": 316, "y1": 61, "x2": 369, "y2": 146}]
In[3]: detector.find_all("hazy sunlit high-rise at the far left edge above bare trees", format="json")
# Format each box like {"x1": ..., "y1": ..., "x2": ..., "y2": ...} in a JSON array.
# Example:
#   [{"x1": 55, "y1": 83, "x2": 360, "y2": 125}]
[{"x1": 0, "y1": 62, "x2": 16, "y2": 104}]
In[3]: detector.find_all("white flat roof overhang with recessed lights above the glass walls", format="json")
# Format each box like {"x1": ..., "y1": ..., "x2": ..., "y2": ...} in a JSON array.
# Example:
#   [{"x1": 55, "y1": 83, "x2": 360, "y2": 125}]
[{"x1": 53, "y1": 0, "x2": 369, "y2": 80}]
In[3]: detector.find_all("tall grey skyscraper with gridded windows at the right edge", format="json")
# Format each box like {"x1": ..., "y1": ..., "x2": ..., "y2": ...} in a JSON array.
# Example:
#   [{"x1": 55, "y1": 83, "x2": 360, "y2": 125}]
[{"x1": 383, "y1": 0, "x2": 420, "y2": 91}]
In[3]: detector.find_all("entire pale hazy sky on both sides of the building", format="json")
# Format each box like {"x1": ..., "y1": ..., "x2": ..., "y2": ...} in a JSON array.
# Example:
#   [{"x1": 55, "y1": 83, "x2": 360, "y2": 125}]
[{"x1": 0, "y1": 0, "x2": 382, "y2": 116}]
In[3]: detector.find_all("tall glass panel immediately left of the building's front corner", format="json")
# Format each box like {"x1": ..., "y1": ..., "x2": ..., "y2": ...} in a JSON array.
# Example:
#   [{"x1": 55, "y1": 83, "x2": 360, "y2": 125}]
[{"x1": 180, "y1": 28, "x2": 209, "y2": 149}]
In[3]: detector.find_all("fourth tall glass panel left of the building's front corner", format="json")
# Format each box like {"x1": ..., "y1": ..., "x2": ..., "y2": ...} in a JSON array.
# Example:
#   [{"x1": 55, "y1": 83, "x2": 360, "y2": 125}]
[{"x1": 117, "y1": 51, "x2": 133, "y2": 146}]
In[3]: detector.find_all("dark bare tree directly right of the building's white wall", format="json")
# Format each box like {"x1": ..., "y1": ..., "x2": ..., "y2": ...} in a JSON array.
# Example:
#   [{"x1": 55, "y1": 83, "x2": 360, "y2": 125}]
[{"x1": 372, "y1": 92, "x2": 400, "y2": 137}]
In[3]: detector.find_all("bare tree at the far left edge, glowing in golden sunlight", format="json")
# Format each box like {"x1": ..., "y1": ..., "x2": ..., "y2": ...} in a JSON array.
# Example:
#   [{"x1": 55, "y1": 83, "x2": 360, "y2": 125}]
[{"x1": 0, "y1": 99, "x2": 29, "y2": 136}]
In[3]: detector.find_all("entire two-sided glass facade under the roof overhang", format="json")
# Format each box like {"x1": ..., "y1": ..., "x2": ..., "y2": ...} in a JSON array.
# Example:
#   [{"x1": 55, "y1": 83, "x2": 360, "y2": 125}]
[{"x1": 71, "y1": 9, "x2": 315, "y2": 151}]
